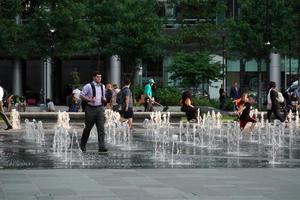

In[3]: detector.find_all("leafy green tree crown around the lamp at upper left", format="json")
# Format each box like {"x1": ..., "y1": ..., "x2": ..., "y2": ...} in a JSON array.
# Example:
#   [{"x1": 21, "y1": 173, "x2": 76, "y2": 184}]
[{"x1": 24, "y1": 0, "x2": 90, "y2": 58}]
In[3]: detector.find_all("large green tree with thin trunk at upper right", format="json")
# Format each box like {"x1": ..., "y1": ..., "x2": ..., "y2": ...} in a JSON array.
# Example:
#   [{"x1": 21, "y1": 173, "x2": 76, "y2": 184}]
[{"x1": 225, "y1": 0, "x2": 293, "y2": 108}]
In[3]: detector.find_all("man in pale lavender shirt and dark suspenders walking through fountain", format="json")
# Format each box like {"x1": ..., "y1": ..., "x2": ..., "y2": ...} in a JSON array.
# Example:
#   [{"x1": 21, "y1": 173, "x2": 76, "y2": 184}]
[{"x1": 80, "y1": 71, "x2": 107, "y2": 152}]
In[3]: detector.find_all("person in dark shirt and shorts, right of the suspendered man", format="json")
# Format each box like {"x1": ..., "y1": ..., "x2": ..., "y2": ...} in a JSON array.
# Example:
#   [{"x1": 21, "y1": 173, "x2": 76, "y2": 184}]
[{"x1": 120, "y1": 79, "x2": 133, "y2": 128}]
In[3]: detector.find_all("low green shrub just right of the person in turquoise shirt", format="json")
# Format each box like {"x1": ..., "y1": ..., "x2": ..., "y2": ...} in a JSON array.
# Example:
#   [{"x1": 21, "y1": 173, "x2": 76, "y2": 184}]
[{"x1": 154, "y1": 87, "x2": 181, "y2": 106}]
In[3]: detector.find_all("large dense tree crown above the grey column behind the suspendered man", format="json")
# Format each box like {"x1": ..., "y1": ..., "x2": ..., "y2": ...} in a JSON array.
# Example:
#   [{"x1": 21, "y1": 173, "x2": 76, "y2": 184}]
[{"x1": 89, "y1": 0, "x2": 163, "y2": 78}]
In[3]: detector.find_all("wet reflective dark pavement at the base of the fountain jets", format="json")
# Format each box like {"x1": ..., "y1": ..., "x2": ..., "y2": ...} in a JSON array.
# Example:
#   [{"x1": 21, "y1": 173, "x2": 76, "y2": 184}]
[{"x1": 0, "y1": 133, "x2": 300, "y2": 168}]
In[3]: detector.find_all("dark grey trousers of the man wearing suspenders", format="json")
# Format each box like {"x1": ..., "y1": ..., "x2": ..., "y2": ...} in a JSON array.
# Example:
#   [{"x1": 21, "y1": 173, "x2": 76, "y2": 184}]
[{"x1": 80, "y1": 106, "x2": 105, "y2": 149}]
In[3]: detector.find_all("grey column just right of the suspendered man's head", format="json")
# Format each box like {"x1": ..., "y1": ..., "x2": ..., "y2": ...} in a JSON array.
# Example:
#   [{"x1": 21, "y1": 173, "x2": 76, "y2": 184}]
[{"x1": 108, "y1": 55, "x2": 121, "y2": 88}]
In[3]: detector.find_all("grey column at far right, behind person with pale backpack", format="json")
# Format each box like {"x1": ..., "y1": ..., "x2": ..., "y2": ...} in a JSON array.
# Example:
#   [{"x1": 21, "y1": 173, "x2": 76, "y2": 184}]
[{"x1": 270, "y1": 53, "x2": 281, "y2": 90}]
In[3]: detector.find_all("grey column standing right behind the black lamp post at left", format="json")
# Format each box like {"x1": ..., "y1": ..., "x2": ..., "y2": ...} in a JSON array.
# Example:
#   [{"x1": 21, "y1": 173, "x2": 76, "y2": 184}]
[{"x1": 42, "y1": 57, "x2": 53, "y2": 100}]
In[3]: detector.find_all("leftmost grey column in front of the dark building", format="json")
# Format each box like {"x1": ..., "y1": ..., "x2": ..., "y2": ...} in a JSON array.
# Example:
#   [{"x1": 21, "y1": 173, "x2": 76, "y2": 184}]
[{"x1": 13, "y1": 58, "x2": 23, "y2": 96}]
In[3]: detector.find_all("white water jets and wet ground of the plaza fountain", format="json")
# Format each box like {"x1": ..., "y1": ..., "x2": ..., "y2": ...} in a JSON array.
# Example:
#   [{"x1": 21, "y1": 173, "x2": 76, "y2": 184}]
[{"x1": 0, "y1": 106, "x2": 300, "y2": 168}]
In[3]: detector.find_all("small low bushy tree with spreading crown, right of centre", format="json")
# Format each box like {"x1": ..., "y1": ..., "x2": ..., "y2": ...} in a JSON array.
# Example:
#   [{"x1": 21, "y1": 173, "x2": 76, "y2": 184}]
[{"x1": 168, "y1": 52, "x2": 221, "y2": 87}]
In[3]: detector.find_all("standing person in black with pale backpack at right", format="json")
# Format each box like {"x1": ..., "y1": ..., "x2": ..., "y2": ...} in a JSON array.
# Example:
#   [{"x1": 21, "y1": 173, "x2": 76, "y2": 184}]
[{"x1": 267, "y1": 81, "x2": 286, "y2": 122}]
